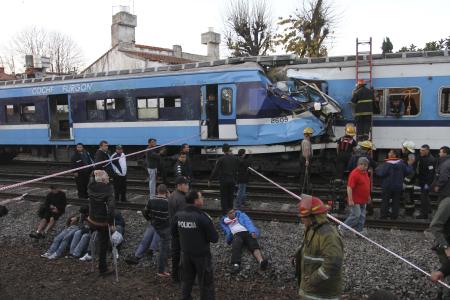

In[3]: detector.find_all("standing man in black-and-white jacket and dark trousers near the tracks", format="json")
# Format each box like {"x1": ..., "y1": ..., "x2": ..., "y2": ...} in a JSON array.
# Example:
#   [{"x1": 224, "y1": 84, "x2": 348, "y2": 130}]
[{"x1": 111, "y1": 145, "x2": 127, "y2": 202}]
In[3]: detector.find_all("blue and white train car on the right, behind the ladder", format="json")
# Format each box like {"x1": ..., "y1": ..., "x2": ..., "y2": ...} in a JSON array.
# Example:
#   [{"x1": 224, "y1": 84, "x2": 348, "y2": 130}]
[{"x1": 287, "y1": 50, "x2": 450, "y2": 149}]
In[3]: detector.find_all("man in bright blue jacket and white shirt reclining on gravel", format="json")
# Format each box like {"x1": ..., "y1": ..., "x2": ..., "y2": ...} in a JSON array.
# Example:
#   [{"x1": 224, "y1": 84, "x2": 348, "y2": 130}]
[{"x1": 220, "y1": 209, "x2": 268, "y2": 273}]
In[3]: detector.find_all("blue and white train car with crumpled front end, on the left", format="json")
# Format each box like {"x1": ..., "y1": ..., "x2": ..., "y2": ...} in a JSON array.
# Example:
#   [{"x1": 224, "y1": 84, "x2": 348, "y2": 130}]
[{"x1": 0, "y1": 62, "x2": 340, "y2": 162}]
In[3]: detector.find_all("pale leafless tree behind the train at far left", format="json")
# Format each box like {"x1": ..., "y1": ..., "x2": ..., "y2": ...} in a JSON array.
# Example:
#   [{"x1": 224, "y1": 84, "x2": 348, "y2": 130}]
[{"x1": 10, "y1": 27, "x2": 83, "y2": 74}]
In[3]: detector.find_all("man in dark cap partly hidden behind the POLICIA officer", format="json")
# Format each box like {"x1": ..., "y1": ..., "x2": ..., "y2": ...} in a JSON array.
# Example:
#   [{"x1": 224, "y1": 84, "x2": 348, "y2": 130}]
[{"x1": 168, "y1": 176, "x2": 189, "y2": 282}]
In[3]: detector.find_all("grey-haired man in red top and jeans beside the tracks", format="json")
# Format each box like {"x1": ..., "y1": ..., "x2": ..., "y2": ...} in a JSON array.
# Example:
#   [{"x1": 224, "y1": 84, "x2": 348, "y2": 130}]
[{"x1": 339, "y1": 157, "x2": 371, "y2": 232}]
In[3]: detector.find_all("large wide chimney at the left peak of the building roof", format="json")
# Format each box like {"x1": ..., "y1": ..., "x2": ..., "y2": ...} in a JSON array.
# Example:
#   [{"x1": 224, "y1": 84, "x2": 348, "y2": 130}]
[{"x1": 111, "y1": 7, "x2": 137, "y2": 47}]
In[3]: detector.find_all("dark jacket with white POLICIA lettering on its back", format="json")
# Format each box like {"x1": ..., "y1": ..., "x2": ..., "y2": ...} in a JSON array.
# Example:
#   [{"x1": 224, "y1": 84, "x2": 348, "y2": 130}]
[{"x1": 172, "y1": 205, "x2": 219, "y2": 257}]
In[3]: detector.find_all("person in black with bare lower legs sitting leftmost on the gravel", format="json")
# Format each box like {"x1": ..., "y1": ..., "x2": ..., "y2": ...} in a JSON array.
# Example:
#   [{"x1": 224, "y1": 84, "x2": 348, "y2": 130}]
[{"x1": 30, "y1": 185, "x2": 67, "y2": 239}]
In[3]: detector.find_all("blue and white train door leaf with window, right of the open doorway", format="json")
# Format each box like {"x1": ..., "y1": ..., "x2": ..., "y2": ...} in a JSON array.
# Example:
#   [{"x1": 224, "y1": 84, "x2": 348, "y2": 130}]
[{"x1": 218, "y1": 84, "x2": 237, "y2": 140}]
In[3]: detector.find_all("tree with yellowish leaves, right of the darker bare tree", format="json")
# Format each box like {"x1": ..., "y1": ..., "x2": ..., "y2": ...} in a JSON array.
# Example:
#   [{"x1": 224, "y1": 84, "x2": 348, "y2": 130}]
[{"x1": 276, "y1": 0, "x2": 336, "y2": 57}]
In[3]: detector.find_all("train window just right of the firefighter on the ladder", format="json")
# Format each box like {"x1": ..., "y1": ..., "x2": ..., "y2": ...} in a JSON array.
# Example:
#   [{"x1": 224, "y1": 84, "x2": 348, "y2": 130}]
[{"x1": 388, "y1": 88, "x2": 420, "y2": 116}]
